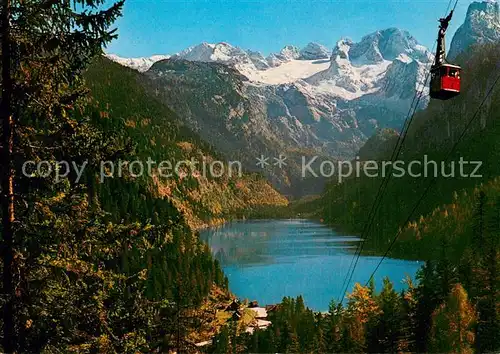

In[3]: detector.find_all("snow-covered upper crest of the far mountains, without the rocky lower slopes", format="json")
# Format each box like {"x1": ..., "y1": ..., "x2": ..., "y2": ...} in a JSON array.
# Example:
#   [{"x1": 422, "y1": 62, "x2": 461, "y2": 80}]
[{"x1": 148, "y1": 28, "x2": 431, "y2": 100}]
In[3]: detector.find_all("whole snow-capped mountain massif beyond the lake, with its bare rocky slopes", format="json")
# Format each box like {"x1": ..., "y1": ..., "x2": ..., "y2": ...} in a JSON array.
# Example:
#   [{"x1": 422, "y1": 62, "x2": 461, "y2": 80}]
[{"x1": 139, "y1": 28, "x2": 432, "y2": 165}]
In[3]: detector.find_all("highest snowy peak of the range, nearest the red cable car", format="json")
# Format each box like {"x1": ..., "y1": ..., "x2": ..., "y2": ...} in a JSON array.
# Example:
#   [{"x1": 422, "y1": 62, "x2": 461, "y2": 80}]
[{"x1": 305, "y1": 28, "x2": 432, "y2": 99}]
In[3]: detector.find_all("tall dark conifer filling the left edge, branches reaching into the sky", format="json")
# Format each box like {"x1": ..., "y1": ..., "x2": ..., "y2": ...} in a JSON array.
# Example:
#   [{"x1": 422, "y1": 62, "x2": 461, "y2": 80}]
[{"x1": 0, "y1": 0, "x2": 123, "y2": 352}]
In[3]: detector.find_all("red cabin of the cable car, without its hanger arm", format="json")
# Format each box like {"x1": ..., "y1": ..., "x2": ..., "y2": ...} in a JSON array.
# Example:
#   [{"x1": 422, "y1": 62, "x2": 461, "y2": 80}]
[{"x1": 430, "y1": 64, "x2": 462, "y2": 100}]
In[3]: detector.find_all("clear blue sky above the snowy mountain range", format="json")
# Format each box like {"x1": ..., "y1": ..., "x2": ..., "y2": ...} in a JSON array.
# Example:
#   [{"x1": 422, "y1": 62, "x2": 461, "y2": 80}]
[{"x1": 106, "y1": 0, "x2": 470, "y2": 57}]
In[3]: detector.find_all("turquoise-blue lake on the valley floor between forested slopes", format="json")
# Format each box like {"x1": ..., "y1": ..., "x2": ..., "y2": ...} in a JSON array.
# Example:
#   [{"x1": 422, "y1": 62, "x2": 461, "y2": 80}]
[{"x1": 201, "y1": 220, "x2": 423, "y2": 311}]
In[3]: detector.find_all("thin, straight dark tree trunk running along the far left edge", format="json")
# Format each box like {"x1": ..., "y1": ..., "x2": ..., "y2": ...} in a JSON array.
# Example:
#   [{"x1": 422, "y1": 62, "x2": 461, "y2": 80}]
[{"x1": 0, "y1": 0, "x2": 16, "y2": 353}]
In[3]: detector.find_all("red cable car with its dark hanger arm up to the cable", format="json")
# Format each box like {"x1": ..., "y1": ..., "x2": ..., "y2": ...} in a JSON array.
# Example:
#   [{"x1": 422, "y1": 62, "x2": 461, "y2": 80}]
[{"x1": 430, "y1": 10, "x2": 462, "y2": 100}]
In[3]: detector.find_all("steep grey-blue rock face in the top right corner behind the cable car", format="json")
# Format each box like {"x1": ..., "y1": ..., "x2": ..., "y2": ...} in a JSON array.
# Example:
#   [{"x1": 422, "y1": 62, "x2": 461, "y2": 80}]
[{"x1": 448, "y1": 1, "x2": 500, "y2": 60}]
